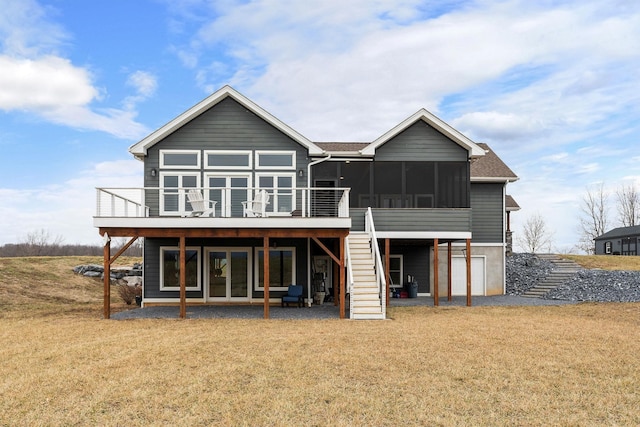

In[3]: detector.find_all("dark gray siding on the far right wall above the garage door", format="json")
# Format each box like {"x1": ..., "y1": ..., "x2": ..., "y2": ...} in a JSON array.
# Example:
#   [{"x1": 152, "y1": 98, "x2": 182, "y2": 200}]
[{"x1": 471, "y1": 183, "x2": 504, "y2": 243}]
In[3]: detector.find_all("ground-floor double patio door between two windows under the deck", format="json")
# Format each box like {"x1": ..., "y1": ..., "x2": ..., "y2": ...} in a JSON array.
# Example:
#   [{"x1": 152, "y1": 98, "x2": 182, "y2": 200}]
[{"x1": 206, "y1": 248, "x2": 251, "y2": 301}]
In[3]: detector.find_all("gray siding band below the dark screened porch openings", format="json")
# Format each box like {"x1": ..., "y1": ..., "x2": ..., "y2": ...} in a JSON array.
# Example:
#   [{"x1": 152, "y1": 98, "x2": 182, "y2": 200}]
[{"x1": 350, "y1": 209, "x2": 471, "y2": 232}]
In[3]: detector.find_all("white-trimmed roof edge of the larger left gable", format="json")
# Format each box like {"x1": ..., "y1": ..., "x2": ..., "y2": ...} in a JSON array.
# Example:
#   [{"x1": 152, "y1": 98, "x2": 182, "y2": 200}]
[{"x1": 129, "y1": 85, "x2": 324, "y2": 159}]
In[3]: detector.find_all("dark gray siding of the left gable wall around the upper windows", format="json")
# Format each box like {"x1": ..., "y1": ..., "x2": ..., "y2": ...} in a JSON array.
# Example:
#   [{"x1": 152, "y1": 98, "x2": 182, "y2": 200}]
[{"x1": 144, "y1": 98, "x2": 309, "y2": 215}]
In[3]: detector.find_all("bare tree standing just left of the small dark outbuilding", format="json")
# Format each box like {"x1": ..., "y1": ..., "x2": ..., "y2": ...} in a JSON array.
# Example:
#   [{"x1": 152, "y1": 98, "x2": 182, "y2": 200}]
[{"x1": 578, "y1": 184, "x2": 609, "y2": 254}]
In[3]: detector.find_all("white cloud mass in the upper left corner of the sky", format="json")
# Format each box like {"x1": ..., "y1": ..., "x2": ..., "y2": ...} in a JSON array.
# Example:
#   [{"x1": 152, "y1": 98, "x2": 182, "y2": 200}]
[{"x1": 0, "y1": 0, "x2": 151, "y2": 139}]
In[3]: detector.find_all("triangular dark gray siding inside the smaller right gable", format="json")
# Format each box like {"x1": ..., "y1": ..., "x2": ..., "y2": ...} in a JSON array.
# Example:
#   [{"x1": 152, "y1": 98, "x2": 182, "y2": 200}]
[{"x1": 375, "y1": 120, "x2": 468, "y2": 161}]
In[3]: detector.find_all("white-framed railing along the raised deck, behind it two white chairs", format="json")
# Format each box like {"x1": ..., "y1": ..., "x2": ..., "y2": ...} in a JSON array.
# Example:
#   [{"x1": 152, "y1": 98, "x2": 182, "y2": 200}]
[{"x1": 96, "y1": 187, "x2": 349, "y2": 218}]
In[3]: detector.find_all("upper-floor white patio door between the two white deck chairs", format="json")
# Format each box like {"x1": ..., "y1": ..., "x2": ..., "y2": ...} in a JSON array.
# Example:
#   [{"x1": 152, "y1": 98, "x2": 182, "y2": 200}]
[{"x1": 206, "y1": 174, "x2": 251, "y2": 218}]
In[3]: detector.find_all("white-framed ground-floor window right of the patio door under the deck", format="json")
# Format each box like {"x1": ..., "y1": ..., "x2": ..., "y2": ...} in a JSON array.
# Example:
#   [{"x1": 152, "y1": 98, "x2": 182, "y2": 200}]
[{"x1": 256, "y1": 247, "x2": 296, "y2": 291}]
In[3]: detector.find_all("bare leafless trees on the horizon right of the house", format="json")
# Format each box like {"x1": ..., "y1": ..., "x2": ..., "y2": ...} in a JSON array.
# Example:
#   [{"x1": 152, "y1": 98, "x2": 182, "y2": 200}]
[{"x1": 516, "y1": 183, "x2": 640, "y2": 254}]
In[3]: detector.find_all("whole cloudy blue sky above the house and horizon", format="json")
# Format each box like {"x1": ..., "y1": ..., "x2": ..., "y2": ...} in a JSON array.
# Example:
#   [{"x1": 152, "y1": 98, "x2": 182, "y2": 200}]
[{"x1": 0, "y1": 0, "x2": 640, "y2": 251}]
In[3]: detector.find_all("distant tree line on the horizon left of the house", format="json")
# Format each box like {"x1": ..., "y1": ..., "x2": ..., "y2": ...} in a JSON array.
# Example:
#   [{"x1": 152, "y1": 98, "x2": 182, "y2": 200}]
[{"x1": 0, "y1": 229, "x2": 142, "y2": 257}]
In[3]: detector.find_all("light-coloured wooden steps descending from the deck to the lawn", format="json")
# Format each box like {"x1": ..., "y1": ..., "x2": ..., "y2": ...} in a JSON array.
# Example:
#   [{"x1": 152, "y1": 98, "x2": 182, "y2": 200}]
[{"x1": 348, "y1": 233, "x2": 386, "y2": 319}]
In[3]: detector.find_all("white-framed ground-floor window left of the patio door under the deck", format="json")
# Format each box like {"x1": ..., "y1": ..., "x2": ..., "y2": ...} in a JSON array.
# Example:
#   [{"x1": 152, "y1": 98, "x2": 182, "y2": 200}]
[{"x1": 160, "y1": 246, "x2": 200, "y2": 291}]
